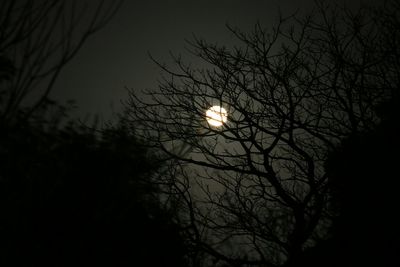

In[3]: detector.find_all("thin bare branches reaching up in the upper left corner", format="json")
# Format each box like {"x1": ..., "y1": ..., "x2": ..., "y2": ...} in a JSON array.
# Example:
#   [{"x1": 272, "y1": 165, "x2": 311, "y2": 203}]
[{"x1": 0, "y1": 0, "x2": 122, "y2": 121}]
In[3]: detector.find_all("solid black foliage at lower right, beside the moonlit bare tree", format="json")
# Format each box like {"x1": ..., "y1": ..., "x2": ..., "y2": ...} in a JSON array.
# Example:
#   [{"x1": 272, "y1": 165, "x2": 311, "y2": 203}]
[{"x1": 294, "y1": 97, "x2": 400, "y2": 267}]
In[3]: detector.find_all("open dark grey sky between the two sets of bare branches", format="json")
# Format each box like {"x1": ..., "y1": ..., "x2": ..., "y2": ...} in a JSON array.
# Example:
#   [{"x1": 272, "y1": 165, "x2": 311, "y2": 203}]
[{"x1": 53, "y1": 0, "x2": 368, "y2": 120}]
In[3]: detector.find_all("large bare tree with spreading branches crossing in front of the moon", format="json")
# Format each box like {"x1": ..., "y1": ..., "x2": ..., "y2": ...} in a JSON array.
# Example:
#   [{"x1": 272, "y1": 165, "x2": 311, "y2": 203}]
[{"x1": 127, "y1": 1, "x2": 400, "y2": 266}]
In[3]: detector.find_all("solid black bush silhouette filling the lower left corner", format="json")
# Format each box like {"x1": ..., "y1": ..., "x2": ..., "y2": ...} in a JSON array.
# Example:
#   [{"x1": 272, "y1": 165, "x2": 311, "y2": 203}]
[{"x1": 0, "y1": 116, "x2": 188, "y2": 266}]
